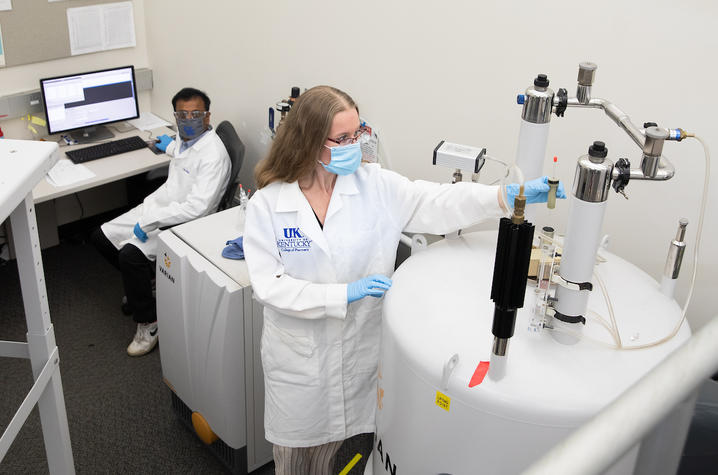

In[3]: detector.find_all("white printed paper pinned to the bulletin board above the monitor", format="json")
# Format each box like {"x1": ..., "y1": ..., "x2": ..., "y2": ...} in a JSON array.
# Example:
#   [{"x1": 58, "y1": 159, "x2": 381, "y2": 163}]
[{"x1": 67, "y1": 2, "x2": 136, "y2": 56}]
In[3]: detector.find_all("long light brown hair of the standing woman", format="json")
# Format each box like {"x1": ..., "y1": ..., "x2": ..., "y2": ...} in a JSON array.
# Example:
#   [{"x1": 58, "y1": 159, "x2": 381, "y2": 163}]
[{"x1": 254, "y1": 86, "x2": 359, "y2": 188}]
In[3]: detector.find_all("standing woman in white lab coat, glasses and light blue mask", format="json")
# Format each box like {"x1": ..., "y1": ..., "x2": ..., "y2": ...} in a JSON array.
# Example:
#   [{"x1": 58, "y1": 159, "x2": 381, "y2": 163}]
[{"x1": 244, "y1": 86, "x2": 548, "y2": 474}]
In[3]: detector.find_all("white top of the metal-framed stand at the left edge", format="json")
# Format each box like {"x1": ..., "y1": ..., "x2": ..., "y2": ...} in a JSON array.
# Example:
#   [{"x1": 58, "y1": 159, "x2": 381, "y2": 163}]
[{"x1": 0, "y1": 139, "x2": 60, "y2": 222}]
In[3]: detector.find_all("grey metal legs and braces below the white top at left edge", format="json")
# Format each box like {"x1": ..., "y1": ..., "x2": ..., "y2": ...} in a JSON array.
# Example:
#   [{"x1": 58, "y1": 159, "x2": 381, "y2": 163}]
[{"x1": 0, "y1": 192, "x2": 75, "y2": 474}]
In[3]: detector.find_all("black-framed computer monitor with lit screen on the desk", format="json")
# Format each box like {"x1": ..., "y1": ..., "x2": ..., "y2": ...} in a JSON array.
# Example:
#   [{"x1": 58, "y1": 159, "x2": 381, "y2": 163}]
[{"x1": 40, "y1": 66, "x2": 140, "y2": 143}]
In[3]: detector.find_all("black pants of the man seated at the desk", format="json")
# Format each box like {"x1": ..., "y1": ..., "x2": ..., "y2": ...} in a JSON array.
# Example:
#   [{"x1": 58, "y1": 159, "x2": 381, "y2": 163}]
[{"x1": 90, "y1": 228, "x2": 157, "y2": 323}]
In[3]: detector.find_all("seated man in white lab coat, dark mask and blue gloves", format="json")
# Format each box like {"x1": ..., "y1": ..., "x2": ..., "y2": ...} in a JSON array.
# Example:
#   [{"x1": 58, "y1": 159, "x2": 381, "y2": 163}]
[{"x1": 91, "y1": 88, "x2": 231, "y2": 356}]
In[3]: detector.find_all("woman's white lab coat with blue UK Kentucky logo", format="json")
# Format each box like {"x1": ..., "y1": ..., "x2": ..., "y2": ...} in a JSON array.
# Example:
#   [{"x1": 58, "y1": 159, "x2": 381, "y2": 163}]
[{"x1": 244, "y1": 164, "x2": 503, "y2": 447}]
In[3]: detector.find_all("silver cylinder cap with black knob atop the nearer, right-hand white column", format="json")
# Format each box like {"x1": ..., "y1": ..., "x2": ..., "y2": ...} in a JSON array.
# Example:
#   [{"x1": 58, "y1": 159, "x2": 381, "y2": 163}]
[{"x1": 573, "y1": 142, "x2": 613, "y2": 203}]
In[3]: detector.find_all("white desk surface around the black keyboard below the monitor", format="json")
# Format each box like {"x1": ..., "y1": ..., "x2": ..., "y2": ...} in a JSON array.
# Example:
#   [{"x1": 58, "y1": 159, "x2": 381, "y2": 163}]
[{"x1": 32, "y1": 127, "x2": 175, "y2": 204}]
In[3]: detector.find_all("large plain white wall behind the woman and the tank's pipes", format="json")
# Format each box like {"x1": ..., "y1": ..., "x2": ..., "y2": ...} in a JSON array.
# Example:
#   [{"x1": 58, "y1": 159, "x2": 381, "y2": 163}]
[{"x1": 9, "y1": 0, "x2": 718, "y2": 327}]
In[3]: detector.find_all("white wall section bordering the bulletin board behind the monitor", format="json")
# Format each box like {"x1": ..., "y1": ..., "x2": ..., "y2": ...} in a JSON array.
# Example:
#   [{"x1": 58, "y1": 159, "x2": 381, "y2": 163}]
[{"x1": 0, "y1": 0, "x2": 150, "y2": 139}]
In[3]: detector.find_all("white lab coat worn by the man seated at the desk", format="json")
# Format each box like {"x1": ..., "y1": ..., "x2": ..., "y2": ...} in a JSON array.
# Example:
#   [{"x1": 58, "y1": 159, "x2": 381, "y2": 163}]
[{"x1": 102, "y1": 129, "x2": 232, "y2": 260}]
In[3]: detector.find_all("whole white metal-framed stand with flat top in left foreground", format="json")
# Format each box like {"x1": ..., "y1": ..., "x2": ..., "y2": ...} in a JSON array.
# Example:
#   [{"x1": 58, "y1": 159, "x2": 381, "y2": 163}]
[{"x1": 0, "y1": 139, "x2": 75, "y2": 474}]
